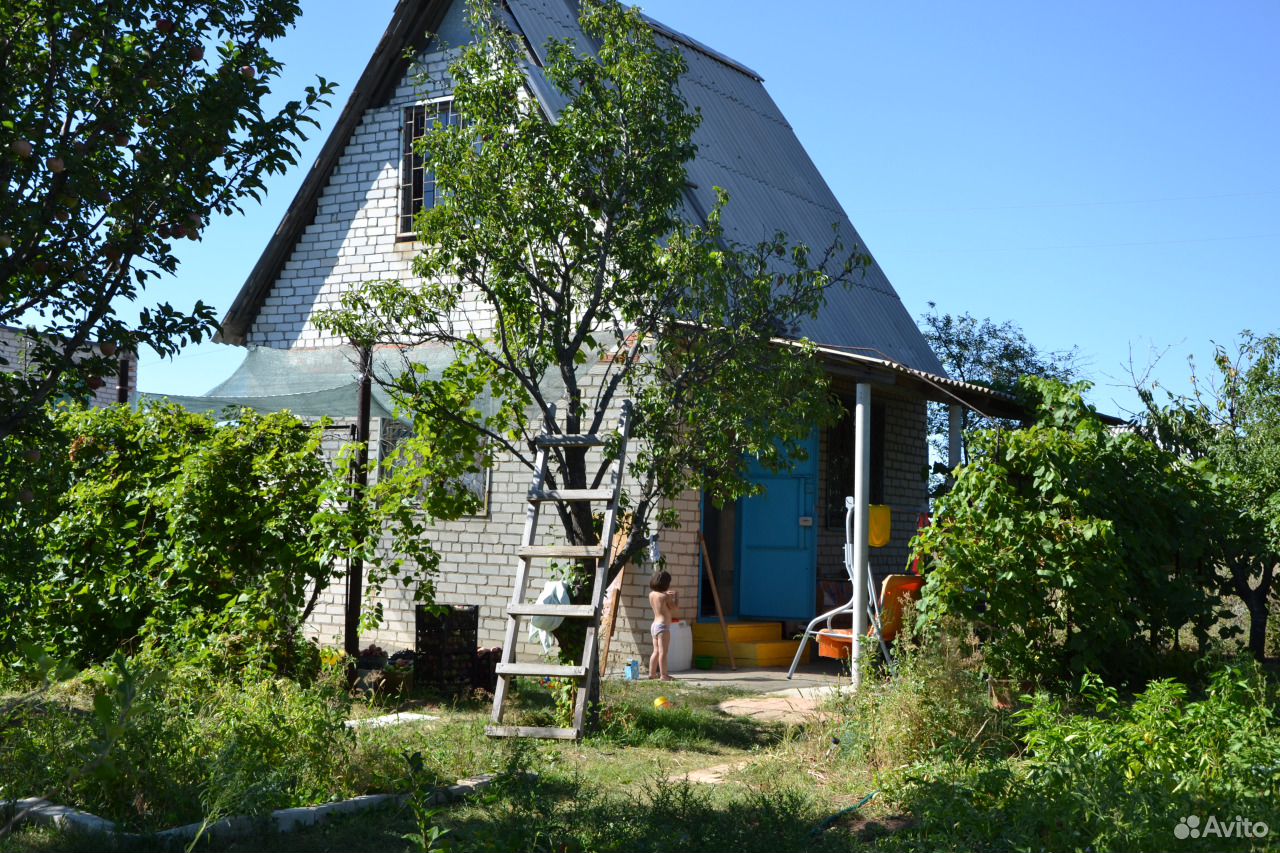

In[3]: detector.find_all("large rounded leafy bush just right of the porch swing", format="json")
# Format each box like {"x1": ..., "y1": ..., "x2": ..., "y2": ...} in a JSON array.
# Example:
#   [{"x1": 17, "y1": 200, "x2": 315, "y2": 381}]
[{"x1": 914, "y1": 378, "x2": 1217, "y2": 683}]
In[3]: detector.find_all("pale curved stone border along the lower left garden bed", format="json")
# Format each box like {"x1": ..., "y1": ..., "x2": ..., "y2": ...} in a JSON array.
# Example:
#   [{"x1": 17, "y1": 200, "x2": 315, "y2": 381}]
[{"x1": 0, "y1": 775, "x2": 493, "y2": 844}]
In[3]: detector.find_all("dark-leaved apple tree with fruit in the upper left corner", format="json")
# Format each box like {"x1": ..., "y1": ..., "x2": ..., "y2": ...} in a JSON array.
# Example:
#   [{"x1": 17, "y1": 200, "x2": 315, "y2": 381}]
[{"x1": 0, "y1": 0, "x2": 333, "y2": 437}]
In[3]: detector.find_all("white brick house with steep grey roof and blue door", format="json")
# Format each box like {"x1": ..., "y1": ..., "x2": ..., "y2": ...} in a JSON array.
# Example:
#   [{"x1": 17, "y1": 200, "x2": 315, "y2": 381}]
[{"x1": 202, "y1": 0, "x2": 1009, "y2": 669}]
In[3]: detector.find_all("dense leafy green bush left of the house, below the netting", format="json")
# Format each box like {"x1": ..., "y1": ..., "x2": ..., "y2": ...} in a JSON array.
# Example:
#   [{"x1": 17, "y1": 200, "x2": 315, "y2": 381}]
[{"x1": 0, "y1": 405, "x2": 430, "y2": 669}]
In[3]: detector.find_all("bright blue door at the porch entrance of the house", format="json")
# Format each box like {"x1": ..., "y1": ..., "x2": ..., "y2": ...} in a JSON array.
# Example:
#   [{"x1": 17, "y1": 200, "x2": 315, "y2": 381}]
[{"x1": 736, "y1": 432, "x2": 818, "y2": 619}]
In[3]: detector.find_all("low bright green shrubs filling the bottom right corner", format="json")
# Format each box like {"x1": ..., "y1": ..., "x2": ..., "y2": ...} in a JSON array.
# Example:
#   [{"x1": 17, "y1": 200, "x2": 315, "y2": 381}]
[{"x1": 887, "y1": 665, "x2": 1280, "y2": 850}]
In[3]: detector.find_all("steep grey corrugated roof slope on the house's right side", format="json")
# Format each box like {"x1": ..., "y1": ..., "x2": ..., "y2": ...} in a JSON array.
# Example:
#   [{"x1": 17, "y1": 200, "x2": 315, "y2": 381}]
[{"x1": 508, "y1": 0, "x2": 946, "y2": 375}]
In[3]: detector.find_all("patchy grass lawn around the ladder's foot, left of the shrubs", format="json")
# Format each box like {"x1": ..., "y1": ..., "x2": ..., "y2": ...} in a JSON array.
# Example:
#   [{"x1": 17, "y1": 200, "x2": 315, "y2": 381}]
[{"x1": 0, "y1": 681, "x2": 896, "y2": 853}]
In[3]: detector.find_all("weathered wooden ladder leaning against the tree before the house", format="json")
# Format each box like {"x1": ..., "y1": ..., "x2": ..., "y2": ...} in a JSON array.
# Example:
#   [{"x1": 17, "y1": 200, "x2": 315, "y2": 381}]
[{"x1": 485, "y1": 400, "x2": 631, "y2": 740}]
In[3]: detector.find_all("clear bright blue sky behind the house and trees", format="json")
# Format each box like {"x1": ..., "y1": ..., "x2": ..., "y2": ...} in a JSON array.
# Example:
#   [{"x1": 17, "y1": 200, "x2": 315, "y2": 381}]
[{"x1": 140, "y1": 0, "x2": 1280, "y2": 411}]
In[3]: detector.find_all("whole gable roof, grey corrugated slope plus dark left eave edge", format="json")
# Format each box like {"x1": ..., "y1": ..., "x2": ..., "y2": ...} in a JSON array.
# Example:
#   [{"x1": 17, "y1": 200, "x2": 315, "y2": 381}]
[{"x1": 216, "y1": 0, "x2": 945, "y2": 375}]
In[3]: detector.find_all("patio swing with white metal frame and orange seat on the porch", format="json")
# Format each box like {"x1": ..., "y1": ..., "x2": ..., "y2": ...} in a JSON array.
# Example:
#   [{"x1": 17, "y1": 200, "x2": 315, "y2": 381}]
[{"x1": 787, "y1": 497, "x2": 924, "y2": 679}]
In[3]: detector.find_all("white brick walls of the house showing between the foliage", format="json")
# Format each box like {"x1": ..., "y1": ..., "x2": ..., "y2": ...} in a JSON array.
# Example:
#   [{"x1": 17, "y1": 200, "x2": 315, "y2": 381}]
[{"x1": 248, "y1": 16, "x2": 925, "y2": 669}]
